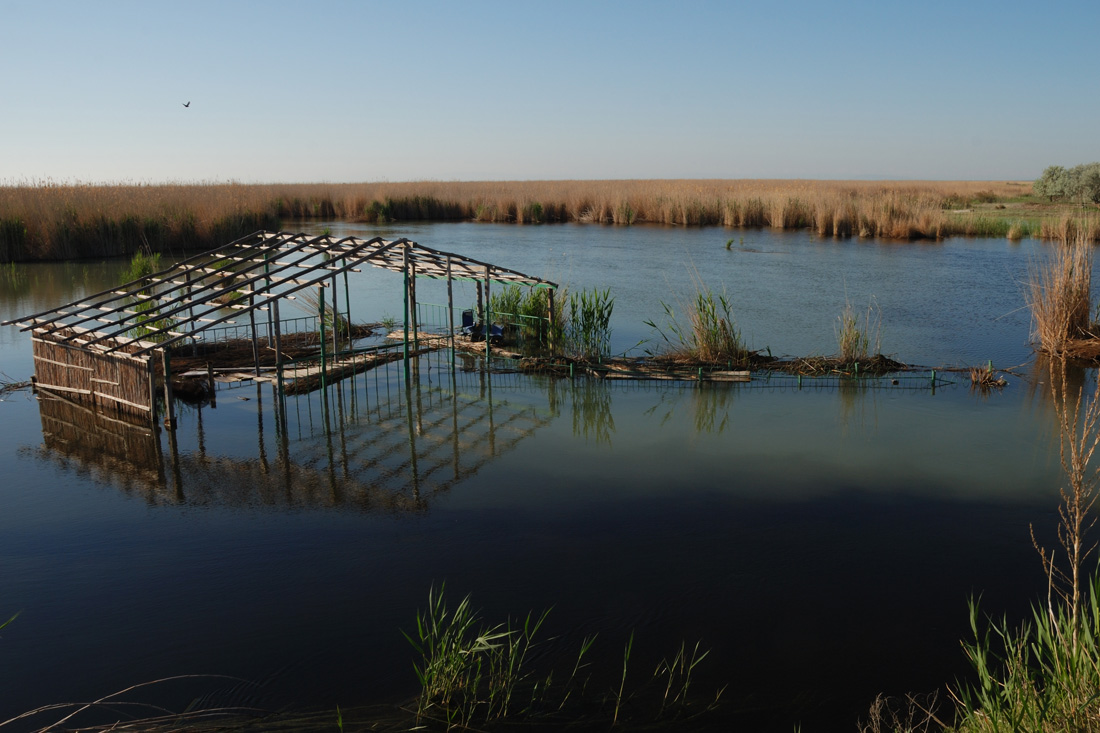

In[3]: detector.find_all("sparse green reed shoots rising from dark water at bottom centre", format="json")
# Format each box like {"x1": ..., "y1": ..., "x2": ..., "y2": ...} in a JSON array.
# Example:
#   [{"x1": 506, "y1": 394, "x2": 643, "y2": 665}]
[{"x1": 403, "y1": 589, "x2": 723, "y2": 730}]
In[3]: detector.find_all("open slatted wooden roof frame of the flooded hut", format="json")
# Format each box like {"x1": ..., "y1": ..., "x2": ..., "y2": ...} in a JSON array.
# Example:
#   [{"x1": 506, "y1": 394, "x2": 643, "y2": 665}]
[{"x1": 0, "y1": 226, "x2": 558, "y2": 358}]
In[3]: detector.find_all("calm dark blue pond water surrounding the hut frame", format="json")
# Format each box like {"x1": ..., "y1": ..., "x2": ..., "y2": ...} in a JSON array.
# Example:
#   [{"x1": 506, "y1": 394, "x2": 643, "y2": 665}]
[{"x1": 0, "y1": 222, "x2": 1082, "y2": 731}]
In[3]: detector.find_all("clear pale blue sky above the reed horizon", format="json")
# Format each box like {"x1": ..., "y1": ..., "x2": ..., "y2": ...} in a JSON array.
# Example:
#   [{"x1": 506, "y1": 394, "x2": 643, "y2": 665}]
[{"x1": 0, "y1": 0, "x2": 1100, "y2": 183}]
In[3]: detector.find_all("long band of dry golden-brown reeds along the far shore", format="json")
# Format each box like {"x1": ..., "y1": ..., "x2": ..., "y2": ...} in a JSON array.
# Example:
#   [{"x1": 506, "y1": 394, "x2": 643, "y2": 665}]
[{"x1": 0, "y1": 179, "x2": 1082, "y2": 262}]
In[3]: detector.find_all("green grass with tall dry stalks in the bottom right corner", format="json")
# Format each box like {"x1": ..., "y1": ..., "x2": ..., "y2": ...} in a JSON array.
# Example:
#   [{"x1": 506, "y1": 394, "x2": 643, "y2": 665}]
[{"x1": 956, "y1": 360, "x2": 1100, "y2": 733}]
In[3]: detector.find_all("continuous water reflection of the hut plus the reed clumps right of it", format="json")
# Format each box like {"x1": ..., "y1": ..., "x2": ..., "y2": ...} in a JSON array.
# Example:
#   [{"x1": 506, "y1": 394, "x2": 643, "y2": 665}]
[{"x1": 30, "y1": 351, "x2": 968, "y2": 513}]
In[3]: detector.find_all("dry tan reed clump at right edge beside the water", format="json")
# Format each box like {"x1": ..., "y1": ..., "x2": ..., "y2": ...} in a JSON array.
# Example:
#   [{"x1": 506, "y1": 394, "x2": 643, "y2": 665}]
[{"x1": 1027, "y1": 230, "x2": 1092, "y2": 355}]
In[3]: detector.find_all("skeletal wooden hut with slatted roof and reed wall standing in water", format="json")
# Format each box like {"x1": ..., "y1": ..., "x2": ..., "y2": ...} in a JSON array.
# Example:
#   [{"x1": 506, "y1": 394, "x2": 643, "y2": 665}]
[{"x1": 2, "y1": 231, "x2": 558, "y2": 426}]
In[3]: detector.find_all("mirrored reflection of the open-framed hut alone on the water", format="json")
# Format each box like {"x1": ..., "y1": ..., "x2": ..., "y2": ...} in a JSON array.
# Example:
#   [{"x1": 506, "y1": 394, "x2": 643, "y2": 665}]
[{"x1": 27, "y1": 354, "x2": 558, "y2": 512}]
